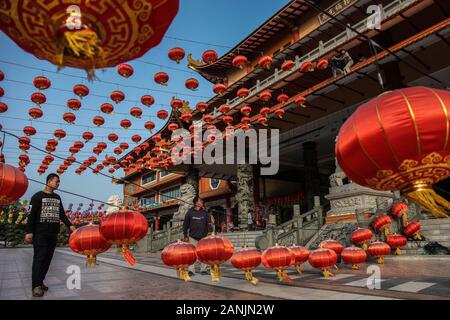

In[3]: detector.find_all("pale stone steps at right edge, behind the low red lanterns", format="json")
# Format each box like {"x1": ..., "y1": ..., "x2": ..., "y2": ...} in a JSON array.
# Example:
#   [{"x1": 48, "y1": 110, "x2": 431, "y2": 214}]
[{"x1": 401, "y1": 219, "x2": 450, "y2": 255}]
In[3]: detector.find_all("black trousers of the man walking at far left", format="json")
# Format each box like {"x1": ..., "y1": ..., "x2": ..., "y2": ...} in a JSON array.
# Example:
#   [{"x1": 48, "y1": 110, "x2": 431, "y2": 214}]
[{"x1": 31, "y1": 233, "x2": 57, "y2": 289}]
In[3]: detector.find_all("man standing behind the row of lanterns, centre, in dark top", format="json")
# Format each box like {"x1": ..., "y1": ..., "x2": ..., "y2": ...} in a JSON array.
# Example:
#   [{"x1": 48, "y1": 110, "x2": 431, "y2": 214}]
[{"x1": 183, "y1": 196, "x2": 213, "y2": 276}]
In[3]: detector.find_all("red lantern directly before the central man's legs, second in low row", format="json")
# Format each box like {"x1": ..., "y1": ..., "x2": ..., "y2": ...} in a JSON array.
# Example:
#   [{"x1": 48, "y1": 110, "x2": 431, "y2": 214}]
[{"x1": 196, "y1": 235, "x2": 234, "y2": 282}]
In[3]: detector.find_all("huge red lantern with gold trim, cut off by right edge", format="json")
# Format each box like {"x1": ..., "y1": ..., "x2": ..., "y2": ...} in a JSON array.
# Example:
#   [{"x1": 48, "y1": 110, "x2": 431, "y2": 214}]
[{"x1": 336, "y1": 87, "x2": 450, "y2": 217}]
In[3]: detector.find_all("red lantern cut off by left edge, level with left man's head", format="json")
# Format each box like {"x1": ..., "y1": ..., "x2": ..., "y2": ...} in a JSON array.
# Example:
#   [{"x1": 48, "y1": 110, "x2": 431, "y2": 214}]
[{"x1": 0, "y1": 162, "x2": 28, "y2": 206}]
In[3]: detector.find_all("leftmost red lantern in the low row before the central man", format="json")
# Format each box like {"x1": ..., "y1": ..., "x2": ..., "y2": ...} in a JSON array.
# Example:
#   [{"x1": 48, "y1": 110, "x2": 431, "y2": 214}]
[{"x1": 161, "y1": 240, "x2": 197, "y2": 281}]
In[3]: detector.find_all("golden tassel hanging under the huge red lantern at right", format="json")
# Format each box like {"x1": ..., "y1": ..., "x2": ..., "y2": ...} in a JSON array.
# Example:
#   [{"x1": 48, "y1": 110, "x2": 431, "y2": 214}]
[{"x1": 406, "y1": 189, "x2": 450, "y2": 218}]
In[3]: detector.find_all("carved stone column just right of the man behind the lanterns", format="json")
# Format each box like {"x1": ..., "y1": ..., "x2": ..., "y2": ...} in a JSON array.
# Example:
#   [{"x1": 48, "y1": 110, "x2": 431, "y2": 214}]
[{"x1": 236, "y1": 164, "x2": 254, "y2": 230}]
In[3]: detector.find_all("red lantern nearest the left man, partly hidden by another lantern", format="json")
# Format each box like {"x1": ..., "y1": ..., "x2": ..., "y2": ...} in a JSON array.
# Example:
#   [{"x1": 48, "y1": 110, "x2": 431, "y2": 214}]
[{"x1": 69, "y1": 224, "x2": 111, "y2": 267}]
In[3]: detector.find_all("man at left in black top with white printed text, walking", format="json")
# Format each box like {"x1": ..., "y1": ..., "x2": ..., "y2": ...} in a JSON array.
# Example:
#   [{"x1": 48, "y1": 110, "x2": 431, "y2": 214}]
[{"x1": 25, "y1": 173, "x2": 75, "y2": 297}]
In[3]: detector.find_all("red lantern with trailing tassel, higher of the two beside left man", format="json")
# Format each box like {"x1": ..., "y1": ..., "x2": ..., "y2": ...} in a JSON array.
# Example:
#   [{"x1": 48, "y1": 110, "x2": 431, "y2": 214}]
[{"x1": 100, "y1": 211, "x2": 148, "y2": 266}]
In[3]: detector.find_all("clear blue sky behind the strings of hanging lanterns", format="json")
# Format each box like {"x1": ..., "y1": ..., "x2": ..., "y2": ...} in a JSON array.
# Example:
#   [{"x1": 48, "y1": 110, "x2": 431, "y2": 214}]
[{"x1": 0, "y1": 0, "x2": 289, "y2": 207}]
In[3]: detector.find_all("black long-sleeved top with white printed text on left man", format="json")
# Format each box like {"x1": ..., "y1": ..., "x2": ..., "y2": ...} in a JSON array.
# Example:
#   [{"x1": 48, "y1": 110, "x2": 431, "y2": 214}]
[{"x1": 25, "y1": 191, "x2": 72, "y2": 234}]
